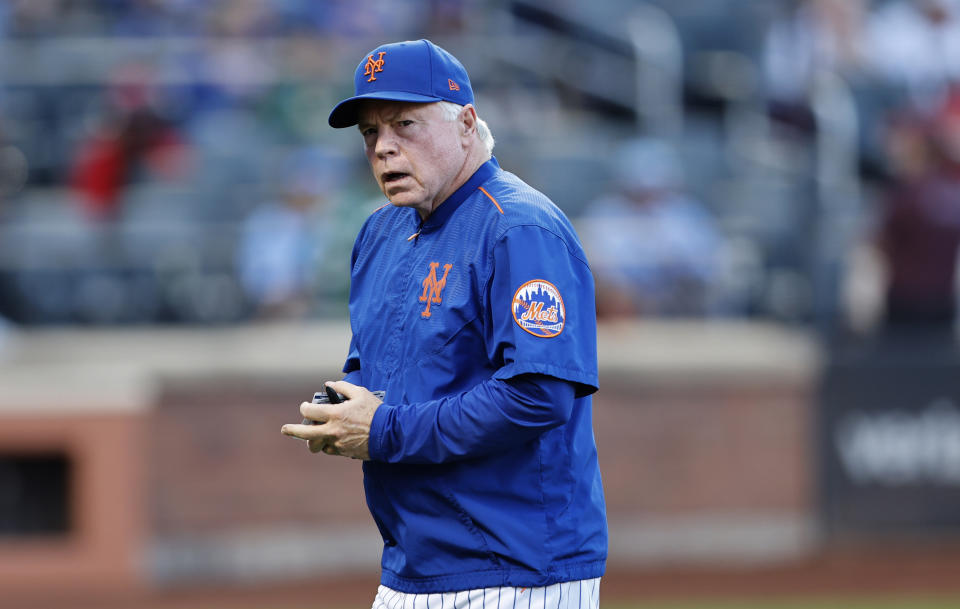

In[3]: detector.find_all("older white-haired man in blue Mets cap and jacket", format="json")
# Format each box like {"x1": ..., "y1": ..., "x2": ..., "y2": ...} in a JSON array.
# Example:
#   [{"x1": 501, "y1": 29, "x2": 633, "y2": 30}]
[{"x1": 283, "y1": 40, "x2": 607, "y2": 608}]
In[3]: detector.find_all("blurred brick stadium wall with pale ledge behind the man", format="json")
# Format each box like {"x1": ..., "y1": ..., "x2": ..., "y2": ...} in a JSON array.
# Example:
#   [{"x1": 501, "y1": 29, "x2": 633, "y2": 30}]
[{"x1": 0, "y1": 322, "x2": 821, "y2": 589}]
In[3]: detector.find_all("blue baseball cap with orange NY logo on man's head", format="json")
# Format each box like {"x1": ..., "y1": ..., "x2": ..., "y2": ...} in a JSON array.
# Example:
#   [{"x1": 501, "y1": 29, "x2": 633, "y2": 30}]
[{"x1": 327, "y1": 40, "x2": 473, "y2": 129}]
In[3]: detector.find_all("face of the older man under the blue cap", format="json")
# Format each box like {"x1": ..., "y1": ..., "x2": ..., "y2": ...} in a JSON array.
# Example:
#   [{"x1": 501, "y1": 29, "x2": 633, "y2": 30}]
[{"x1": 357, "y1": 101, "x2": 466, "y2": 218}]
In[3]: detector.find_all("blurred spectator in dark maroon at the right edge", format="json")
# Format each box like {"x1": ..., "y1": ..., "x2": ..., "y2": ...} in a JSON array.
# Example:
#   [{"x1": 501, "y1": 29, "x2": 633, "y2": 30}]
[{"x1": 878, "y1": 90, "x2": 960, "y2": 329}]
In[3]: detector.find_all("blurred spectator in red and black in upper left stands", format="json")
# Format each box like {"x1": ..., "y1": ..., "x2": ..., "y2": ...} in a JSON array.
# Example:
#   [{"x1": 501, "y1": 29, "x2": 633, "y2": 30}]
[{"x1": 69, "y1": 66, "x2": 187, "y2": 220}]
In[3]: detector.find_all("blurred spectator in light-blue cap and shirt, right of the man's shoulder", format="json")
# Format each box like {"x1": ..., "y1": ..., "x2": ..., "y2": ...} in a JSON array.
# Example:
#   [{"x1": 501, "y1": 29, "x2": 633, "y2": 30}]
[{"x1": 578, "y1": 139, "x2": 721, "y2": 316}]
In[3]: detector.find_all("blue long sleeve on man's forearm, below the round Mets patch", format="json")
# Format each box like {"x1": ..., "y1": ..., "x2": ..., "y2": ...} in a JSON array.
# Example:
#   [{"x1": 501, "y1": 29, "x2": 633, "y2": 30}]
[{"x1": 370, "y1": 374, "x2": 575, "y2": 463}]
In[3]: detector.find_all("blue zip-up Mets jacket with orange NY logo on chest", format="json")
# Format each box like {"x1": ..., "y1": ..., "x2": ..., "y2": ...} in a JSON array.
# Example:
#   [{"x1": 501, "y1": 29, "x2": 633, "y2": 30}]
[{"x1": 344, "y1": 159, "x2": 607, "y2": 593}]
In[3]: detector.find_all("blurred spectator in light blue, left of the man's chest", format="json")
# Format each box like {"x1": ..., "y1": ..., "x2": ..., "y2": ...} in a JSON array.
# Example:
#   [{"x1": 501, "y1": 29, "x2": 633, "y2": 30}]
[{"x1": 237, "y1": 150, "x2": 340, "y2": 317}]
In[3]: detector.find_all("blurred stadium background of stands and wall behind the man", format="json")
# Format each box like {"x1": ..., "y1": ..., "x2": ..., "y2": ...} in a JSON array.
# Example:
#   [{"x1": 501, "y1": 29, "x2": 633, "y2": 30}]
[{"x1": 0, "y1": 0, "x2": 960, "y2": 607}]
